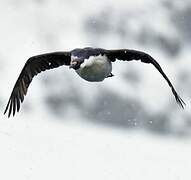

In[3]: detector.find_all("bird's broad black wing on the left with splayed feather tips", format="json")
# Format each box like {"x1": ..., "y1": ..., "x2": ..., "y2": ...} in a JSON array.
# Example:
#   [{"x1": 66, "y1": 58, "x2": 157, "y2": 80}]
[{"x1": 4, "y1": 52, "x2": 71, "y2": 117}]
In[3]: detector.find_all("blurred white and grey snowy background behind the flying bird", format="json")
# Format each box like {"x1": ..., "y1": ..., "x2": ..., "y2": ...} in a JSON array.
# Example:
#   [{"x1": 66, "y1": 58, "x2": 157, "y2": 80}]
[{"x1": 0, "y1": 0, "x2": 191, "y2": 180}]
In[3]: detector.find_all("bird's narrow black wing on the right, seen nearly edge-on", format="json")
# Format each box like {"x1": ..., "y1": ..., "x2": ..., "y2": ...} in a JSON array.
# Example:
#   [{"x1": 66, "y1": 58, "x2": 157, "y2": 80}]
[{"x1": 107, "y1": 49, "x2": 185, "y2": 108}]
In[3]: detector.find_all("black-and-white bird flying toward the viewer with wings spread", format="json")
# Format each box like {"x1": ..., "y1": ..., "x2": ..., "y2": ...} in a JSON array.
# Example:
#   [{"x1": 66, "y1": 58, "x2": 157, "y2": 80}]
[{"x1": 4, "y1": 47, "x2": 185, "y2": 117}]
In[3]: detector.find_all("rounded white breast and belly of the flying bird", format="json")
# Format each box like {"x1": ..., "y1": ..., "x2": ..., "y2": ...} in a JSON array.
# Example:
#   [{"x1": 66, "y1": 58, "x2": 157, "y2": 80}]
[{"x1": 76, "y1": 55, "x2": 112, "y2": 81}]
